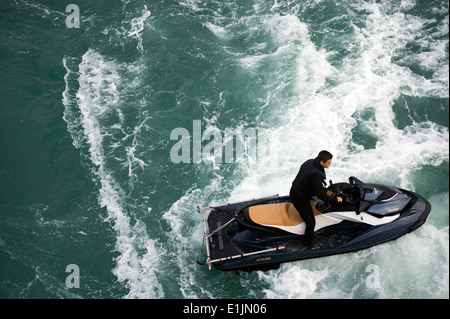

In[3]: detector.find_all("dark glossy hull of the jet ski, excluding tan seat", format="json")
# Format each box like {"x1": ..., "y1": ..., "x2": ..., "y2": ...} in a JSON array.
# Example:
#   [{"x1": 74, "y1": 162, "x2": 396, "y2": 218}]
[{"x1": 201, "y1": 181, "x2": 431, "y2": 271}]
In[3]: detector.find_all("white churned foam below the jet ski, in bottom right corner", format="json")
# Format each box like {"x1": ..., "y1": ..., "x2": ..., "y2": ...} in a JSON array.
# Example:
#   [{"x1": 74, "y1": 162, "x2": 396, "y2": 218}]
[{"x1": 258, "y1": 218, "x2": 449, "y2": 299}]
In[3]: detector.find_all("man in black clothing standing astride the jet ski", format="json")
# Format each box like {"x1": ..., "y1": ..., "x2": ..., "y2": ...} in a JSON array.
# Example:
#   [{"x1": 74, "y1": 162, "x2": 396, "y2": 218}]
[{"x1": 290, "y1": 151, "x2": 342, "y2": 247}]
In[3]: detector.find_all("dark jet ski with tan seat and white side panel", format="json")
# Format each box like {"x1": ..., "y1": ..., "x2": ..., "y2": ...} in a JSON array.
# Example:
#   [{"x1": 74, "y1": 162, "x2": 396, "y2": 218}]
[{"x1": 197, "y1": 176, "x2": 431, "y2": 271}]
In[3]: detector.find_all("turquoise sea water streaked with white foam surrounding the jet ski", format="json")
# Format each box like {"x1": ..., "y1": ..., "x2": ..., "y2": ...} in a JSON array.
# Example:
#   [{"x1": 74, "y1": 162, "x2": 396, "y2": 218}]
[{"x1": 0, "y1": 0, "x2": 449, "y2": 298}]
